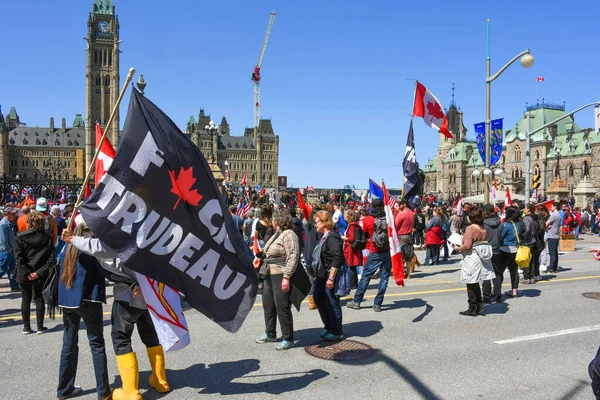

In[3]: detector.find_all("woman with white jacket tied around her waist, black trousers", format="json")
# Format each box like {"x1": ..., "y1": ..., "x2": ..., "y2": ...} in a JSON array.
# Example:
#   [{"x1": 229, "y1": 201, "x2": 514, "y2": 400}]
[{"x1": 454, "y1": 206, "x2": 495, "y2": 317}]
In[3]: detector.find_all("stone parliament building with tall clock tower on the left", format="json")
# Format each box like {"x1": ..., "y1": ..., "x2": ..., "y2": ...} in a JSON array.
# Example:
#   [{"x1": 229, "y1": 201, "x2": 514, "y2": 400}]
[{"x1": 0, "y1": 0, "x2": 279, "y2": 187}]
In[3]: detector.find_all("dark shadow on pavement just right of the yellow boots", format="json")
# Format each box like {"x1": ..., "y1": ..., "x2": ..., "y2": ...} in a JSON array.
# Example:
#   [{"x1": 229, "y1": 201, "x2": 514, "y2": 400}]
[{"x1": 138, "y1": 359, "x2": 329, "y2": 399}]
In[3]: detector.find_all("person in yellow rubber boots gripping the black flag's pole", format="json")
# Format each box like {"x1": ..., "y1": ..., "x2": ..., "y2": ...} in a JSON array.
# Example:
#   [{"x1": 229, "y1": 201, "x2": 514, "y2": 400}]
[{"x1": 62, "y1": 229, "x2": 171, "y2": 400}]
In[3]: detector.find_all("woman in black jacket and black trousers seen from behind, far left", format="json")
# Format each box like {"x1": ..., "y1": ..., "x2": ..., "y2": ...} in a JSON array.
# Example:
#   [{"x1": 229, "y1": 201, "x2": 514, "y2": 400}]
[{"x1": 15, "y1": 211, "x2": 54, "y2": 335}]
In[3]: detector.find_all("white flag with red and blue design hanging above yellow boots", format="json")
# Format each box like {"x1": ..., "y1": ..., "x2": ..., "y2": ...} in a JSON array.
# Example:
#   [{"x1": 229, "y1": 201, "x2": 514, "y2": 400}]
[{"x1": 135, "y1": 272, "x2": 190, "y2": 351}]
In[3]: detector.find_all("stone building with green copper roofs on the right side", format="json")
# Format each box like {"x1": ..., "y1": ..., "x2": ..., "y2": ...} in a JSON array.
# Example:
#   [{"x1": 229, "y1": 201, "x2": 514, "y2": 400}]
[{"x1": 423, "y1": 95, "x2": 600, "y2": 199}]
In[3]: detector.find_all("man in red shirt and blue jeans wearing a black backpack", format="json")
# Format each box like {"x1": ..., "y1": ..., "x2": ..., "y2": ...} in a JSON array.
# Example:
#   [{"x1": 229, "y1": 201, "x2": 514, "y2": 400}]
[{"x1": 346, "y1": 199, "x2": 392, "y2": 312}]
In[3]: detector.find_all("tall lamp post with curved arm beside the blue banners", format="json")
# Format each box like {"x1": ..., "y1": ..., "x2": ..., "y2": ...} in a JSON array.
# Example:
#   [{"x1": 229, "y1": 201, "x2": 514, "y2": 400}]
[{"x1": 483, "y1": 18, "x2": 535, "y2": 204}]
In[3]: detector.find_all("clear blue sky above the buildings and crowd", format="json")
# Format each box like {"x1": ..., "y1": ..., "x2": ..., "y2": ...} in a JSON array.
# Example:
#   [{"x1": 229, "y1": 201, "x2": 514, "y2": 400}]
[{"x1": 0, "y1": 0, "x2": 600, "y2": 188}]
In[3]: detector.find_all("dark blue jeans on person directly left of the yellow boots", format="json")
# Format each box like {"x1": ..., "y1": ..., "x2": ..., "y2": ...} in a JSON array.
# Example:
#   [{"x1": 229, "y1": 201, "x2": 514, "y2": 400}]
[{"x1": 57, "y1": 302, "x2": 110, "y2": 399}]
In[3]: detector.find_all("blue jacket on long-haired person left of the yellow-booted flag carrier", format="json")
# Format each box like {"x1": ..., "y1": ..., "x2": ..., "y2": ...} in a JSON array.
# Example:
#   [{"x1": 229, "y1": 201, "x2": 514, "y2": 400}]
[{"x1": 58, "y1": 251, "x2": 106, "y2": 308}]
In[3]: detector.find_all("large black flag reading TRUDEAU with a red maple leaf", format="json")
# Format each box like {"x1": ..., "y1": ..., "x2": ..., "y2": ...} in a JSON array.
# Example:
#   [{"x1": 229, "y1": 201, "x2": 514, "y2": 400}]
[{"x1": 81, "y1": 89, "x2": 258, "y2": 332}]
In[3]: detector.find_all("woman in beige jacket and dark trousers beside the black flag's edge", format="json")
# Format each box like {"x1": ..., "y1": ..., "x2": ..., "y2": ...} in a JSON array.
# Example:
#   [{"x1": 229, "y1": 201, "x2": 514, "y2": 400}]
[{"x1": 256, "y1": 211, "x2": 300, "y2": 350}]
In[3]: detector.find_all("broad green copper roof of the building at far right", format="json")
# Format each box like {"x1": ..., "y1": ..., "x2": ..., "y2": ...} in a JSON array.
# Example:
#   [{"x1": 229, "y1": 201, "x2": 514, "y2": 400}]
[{"x1": 504, "y1": 108, "x2": 579, "y2": 143}]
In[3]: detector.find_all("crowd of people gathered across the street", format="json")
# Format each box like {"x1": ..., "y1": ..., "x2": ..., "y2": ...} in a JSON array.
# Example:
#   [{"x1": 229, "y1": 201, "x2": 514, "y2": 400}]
[{"x1": 0, "y1": 191, "x2": 600, "y2": 399}]
